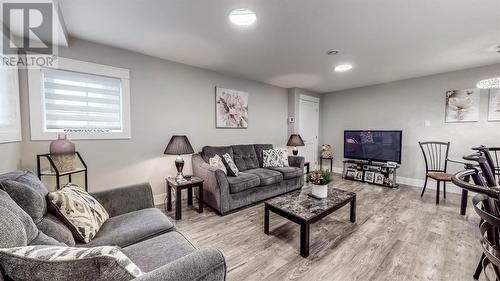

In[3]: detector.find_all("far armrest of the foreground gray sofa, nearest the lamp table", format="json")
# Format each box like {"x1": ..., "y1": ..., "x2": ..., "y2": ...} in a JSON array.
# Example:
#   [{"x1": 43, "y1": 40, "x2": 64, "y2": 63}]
[{"x1": 91, "y1": 183, "x2": 154, "y2": 217}]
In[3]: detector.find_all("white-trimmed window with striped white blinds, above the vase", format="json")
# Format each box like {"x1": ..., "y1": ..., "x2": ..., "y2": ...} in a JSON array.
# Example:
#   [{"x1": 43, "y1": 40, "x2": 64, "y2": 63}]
[{"x1": 28, "y1": 58, "x2": 130, "y2": 140}]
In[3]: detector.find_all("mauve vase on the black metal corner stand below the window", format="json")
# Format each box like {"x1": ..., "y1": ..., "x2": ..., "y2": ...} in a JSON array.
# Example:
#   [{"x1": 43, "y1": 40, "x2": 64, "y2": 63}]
[{"x1": 49, "y1": 135, "x2": 76, "y2": 172}]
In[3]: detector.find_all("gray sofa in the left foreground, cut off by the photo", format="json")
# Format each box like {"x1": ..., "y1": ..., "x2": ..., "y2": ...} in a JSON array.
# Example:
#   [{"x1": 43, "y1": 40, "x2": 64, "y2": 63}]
[{"x1": 0, "y1": 171, "x2": 226, "y2": 281}]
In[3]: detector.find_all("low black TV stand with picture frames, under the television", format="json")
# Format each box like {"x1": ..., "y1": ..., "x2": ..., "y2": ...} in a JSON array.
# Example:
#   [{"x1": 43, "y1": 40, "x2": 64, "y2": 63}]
[{"x1": 342, "y1": 159, "x2": 400, "y2": 188}]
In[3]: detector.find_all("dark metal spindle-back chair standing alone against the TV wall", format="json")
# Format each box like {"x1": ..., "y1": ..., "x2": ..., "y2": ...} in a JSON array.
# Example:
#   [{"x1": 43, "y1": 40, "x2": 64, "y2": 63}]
[{"x1": 418, "y1": 141, "x2": 452, "y2": 204}]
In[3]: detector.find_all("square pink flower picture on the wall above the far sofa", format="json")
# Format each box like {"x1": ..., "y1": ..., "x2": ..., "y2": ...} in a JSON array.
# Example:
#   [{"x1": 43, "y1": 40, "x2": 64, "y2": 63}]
[{"x1": 215, "y1": 87, "x2": 248, "y2": 129}]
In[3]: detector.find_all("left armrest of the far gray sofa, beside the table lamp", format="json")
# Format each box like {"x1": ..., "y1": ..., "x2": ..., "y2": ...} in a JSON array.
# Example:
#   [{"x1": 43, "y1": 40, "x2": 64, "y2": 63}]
[{"x1": 191, "y1": 154, "x2": 229, "y2": 213}]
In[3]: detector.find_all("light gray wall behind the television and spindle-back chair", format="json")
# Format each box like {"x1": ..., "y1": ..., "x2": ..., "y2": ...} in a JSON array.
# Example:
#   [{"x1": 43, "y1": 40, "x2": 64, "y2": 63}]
[{"x1": 321, "y1": 64, "x2": 500, "y2": 189}]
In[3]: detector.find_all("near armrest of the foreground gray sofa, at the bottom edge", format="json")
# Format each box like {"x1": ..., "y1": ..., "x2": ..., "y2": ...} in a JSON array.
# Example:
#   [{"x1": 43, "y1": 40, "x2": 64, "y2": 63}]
[{"x1": 134, "y1": 249, "x2": 226, "y2": 281}]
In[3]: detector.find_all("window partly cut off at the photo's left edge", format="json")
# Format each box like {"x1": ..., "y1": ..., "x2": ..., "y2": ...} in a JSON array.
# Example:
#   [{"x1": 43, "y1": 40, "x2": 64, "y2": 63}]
[{"x1": 0, "y1": 65, "x2": 21, "y2": 143}]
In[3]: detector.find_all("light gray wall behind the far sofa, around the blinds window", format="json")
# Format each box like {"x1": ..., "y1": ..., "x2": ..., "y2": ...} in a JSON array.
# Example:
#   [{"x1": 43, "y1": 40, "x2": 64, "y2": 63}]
[{"x1": 21, "y1": 39, "x2": 288, "y2": 200}]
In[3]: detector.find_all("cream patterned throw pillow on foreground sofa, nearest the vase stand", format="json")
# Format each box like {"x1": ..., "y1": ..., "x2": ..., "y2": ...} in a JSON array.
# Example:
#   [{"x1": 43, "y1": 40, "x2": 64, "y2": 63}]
[{"x1": 47, "y1": 183, "x2": 109, "y2": 243}]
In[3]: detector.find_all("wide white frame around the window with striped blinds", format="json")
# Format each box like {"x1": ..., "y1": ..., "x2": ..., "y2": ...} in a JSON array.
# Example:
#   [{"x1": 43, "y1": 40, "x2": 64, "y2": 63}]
[{"x1": 28, "y1": 57, "x2": 132, "y2": 140}]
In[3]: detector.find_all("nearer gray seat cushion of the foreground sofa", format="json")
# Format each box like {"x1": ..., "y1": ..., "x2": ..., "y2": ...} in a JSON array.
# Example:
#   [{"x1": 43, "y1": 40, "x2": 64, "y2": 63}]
[{"x1": 123, "y1": 231, "x2": 196, "y2": 272}]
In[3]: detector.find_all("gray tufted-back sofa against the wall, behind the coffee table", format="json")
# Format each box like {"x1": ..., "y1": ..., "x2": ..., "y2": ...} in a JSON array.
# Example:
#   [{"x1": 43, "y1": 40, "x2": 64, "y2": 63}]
[{"x1": 192, "y1": 144, "x2": 304, "y2": 215}]
